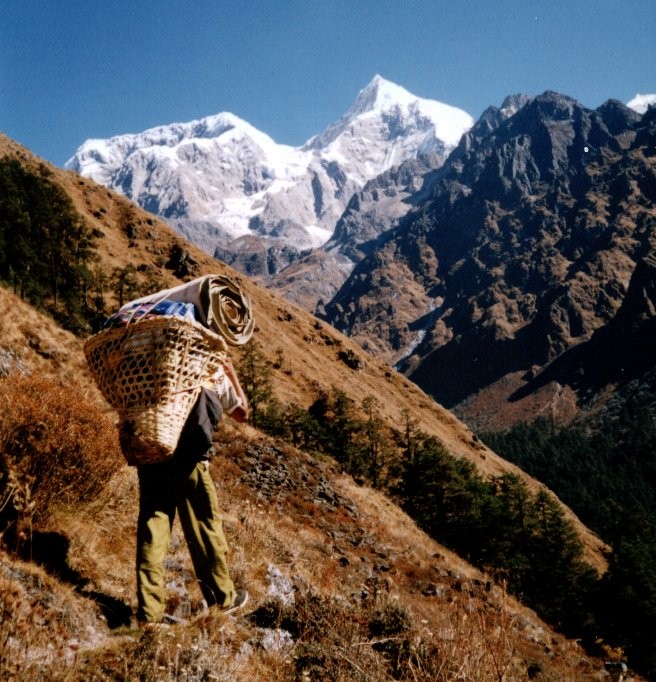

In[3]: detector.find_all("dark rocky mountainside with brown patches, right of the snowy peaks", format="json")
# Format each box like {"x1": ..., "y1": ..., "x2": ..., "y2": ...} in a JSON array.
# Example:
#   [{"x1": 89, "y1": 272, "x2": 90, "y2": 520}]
[{"x1": 326, "y1": 93, "x2": 656, "y2": 428}]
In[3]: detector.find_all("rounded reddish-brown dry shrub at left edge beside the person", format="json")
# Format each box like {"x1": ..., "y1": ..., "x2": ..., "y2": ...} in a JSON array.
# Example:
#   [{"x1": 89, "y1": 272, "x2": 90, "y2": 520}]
[{"x1": 0, "y1": 375, "x2": 123, "y2": 524}]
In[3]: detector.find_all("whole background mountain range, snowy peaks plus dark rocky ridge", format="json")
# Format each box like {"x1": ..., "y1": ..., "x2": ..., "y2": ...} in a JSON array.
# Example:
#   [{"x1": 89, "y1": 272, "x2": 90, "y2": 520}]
[{"x1": 67, "y1": 81, "x2": 656, "y2": 430}]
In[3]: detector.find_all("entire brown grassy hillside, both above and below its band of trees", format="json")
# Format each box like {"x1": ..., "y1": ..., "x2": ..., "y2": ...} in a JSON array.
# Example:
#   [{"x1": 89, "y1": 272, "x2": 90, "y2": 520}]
[{"x1": 0, "y1": 137, "x2": 628, "y2": 682}]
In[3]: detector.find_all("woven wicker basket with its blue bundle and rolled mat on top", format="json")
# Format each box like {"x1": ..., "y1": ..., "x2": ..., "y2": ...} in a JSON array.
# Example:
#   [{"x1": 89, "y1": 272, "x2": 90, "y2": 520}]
[{"x1": 84, "y1": 275, "x2": 255, "y2": 464}]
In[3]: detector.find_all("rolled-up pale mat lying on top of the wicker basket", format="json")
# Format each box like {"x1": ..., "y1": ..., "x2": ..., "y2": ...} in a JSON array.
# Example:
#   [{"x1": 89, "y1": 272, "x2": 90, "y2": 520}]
[{"x1": 121, "y1": 275, "x2": 255, "y2": 346}]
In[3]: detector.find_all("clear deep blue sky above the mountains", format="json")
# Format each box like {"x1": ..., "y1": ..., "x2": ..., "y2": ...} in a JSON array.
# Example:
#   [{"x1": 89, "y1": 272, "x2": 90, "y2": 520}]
[{"x1": 0, "y1": 0, "x2": 656, "y2": 166}]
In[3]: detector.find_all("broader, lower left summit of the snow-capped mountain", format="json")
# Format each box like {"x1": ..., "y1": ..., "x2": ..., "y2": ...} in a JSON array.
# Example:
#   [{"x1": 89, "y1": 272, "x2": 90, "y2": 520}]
[{"x1": 66, "y1": 112, "x2": 320, "y2": 246}]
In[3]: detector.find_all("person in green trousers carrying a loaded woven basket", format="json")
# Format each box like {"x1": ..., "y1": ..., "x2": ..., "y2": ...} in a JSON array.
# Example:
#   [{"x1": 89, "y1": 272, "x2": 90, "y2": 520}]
[{"x1": 84, "y1": 275, "x2": 254, "y2": 625}]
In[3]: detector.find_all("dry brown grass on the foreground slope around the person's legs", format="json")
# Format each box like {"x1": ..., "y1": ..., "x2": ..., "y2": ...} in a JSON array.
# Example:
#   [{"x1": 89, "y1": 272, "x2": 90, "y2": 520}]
[{"x1": 0, "y1": 406, "x2": 632, "y2": 682}]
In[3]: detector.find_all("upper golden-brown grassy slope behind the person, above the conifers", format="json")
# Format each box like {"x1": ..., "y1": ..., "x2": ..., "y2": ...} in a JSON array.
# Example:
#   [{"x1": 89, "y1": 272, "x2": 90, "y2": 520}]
[{"x1": 0, "y1": 129, "x2": 596, "y2": 504}]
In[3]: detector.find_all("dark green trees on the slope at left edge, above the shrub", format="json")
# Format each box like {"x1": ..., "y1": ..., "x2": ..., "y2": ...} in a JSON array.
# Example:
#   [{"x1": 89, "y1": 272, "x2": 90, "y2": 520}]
[{"x1": 0, "y1": 157, "x2": 167, "y2": 335}]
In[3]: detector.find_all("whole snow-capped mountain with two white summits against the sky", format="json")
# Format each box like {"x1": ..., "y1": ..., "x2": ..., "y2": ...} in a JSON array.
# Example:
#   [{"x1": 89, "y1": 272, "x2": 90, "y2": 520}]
[{"x1": 66, "y1": 76, "x2": 473, "y2": 268}]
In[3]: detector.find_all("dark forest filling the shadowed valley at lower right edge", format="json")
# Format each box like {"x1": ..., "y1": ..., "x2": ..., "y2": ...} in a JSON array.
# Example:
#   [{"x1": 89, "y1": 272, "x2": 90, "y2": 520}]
[{"x1": 481, "y1": 378, "x2": 656, "y2": 679}]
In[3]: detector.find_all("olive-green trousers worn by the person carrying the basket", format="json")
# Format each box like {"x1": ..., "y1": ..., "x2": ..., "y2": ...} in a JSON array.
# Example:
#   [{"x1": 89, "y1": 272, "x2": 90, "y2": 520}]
[{"x1": 137, "y1": 457, "x2": 235, "y2": 622}]
